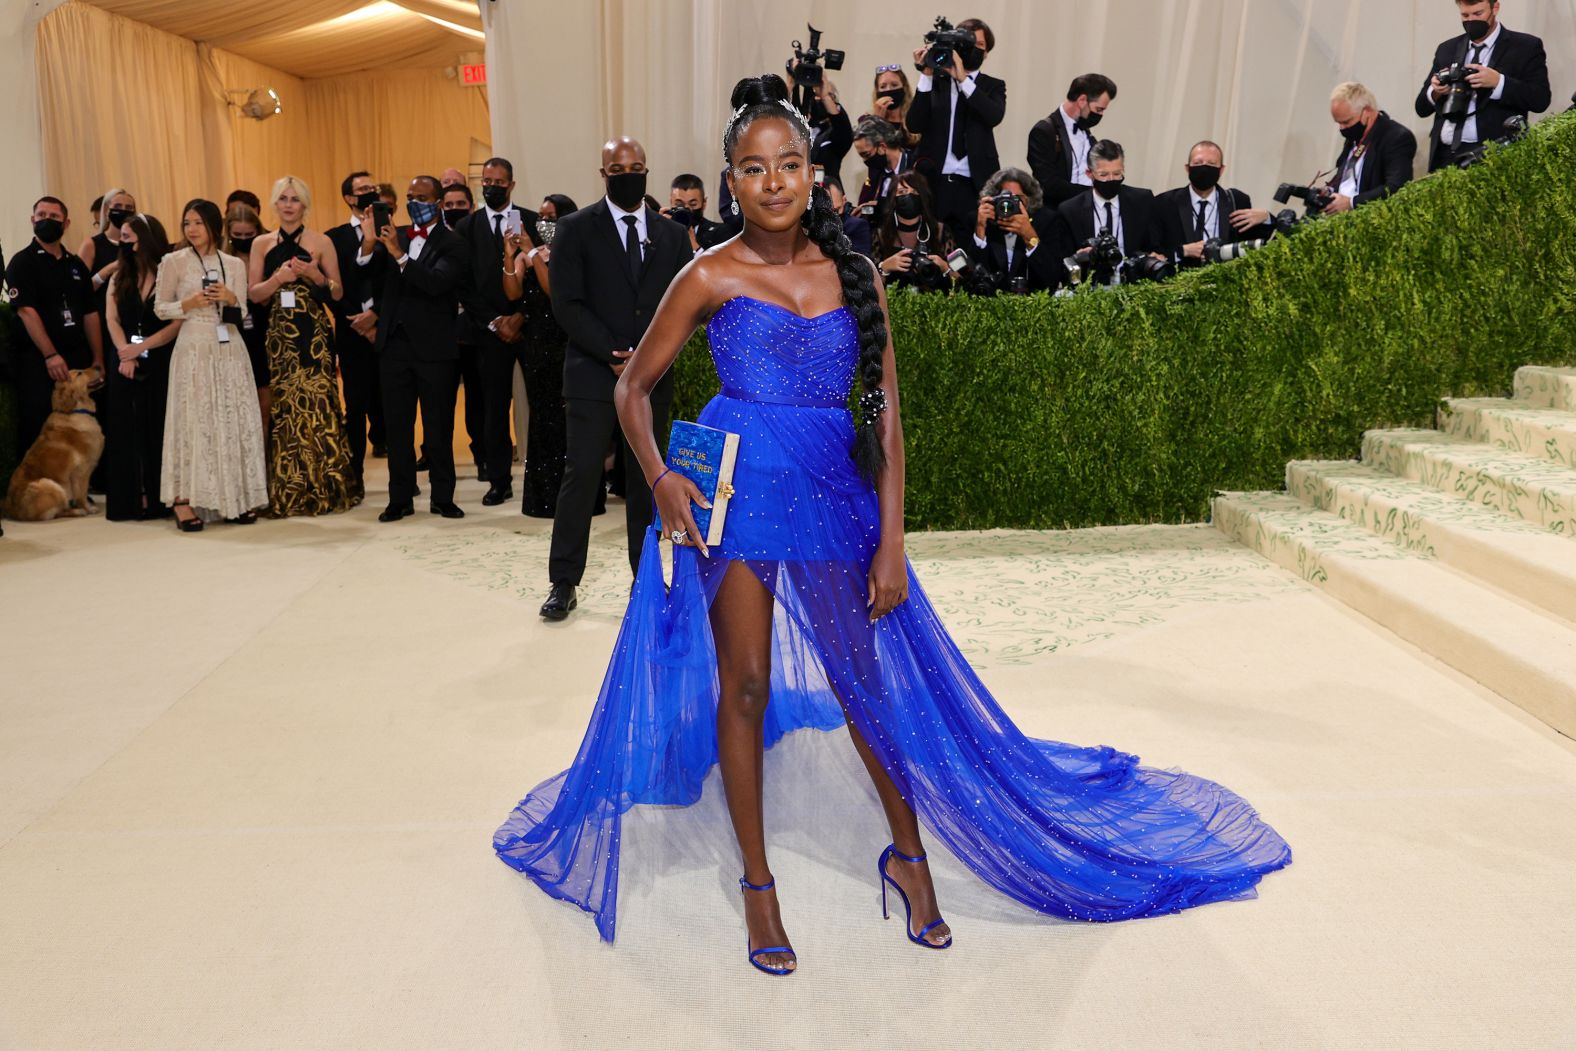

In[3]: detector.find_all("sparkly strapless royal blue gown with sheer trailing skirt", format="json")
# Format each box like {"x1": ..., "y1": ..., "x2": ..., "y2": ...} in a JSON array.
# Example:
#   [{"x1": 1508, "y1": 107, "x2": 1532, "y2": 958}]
[{"x1": 493, "y1": 291, "x2": 1291, "y2": 941}]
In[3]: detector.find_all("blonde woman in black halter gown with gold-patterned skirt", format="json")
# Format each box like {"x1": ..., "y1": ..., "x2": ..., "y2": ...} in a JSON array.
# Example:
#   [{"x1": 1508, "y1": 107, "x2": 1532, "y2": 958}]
[{"x1": 251, "y1": 175, "x2": 362, "y2": 518}]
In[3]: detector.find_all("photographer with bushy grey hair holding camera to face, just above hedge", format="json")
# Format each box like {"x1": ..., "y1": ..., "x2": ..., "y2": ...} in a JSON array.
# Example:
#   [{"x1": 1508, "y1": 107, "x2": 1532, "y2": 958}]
[{"x1": 965, "y1": 169, "x2": 1059, "y2": 292}]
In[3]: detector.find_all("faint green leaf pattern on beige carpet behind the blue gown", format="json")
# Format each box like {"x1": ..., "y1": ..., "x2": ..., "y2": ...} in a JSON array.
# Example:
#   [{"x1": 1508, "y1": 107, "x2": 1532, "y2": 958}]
[{"x1": 399, "y1": 515, "x2": 1302, "y2": 667}]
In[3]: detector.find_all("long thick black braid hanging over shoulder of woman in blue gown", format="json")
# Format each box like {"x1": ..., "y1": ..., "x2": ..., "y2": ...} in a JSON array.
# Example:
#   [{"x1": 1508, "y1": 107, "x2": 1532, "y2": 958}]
[{"x1": 804, "y1": 186, "x2": 887, "y2": 484}]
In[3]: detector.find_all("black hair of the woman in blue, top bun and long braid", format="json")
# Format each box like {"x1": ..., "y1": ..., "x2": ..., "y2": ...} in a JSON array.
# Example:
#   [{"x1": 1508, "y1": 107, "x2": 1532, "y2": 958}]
[{"x1": 722, "y1": 72, "x2": 887, "y2": 484}]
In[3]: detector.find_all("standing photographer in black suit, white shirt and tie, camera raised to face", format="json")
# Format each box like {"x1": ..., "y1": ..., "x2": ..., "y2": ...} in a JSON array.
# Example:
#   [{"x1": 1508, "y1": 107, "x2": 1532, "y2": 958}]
[{"x1": 908, "y1": 19, "x2": 1007, "y2": 247}]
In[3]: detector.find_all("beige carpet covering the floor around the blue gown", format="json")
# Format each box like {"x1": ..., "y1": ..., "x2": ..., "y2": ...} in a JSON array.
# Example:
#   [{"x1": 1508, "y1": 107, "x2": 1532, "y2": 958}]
[{"x1": 0, "y1": 469, "x2": 1576, "y2": 1051}]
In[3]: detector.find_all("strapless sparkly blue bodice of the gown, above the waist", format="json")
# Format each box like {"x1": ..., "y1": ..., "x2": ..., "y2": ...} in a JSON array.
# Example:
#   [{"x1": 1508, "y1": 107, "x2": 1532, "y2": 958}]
[{"x1": 706, "y1": 296, "x2": 859, "y2": 408}]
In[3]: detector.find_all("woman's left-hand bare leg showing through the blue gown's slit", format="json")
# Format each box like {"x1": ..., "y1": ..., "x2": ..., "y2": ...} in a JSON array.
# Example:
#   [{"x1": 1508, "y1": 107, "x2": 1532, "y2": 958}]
[{"x1": 711, "y1": 563, "x2": 796, "y2": 969}]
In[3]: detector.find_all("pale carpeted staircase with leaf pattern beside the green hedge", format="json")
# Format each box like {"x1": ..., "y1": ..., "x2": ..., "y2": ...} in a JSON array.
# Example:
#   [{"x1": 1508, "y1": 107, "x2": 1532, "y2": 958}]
[{"x1": 1214, "y1": 367, "x2": 1576, "y2": 737}]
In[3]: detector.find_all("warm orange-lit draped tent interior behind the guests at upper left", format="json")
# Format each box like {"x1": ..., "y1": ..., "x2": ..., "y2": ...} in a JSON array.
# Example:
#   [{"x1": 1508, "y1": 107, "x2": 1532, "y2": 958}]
[{"x1": 0, "y1": 0, "x2": 492, "y2": 252}]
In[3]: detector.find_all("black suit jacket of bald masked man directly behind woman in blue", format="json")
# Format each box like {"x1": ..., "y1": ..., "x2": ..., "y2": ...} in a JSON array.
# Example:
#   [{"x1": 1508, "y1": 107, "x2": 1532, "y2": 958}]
[{"x1": 548, "y1": 197, "x2": 693, "y2": 402}]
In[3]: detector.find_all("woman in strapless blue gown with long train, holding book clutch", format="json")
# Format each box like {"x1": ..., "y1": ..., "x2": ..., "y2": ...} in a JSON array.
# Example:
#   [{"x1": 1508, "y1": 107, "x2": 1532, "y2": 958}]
[{"x1": 493, "y1": 76, "x2": 1291, "y2": 974}]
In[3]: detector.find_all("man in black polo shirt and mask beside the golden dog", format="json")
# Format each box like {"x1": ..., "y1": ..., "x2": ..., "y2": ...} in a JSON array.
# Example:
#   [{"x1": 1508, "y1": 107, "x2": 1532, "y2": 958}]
[{"x1": 5, "y1": 197, "x2": 104, "y2": 451}]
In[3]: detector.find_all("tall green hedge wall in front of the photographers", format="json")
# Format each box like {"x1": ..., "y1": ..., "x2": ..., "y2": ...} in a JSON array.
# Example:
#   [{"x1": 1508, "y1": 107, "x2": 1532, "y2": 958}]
[{"x1": 675, "y1": 117, "x2": 1576, "y2": 529}]
